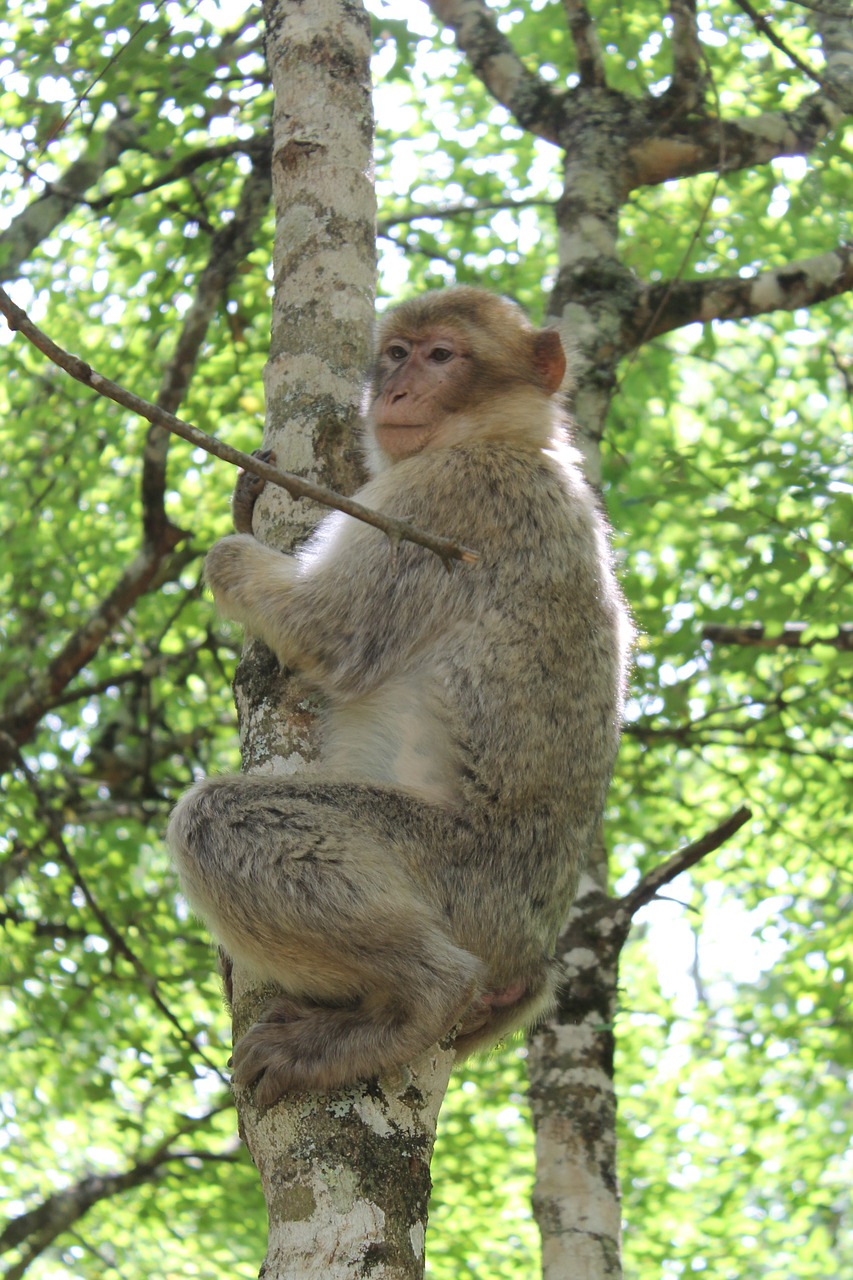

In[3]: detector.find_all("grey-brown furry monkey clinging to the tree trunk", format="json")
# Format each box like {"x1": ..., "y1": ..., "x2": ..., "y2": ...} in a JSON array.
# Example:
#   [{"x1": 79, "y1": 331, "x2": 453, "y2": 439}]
[{"x1": 169, "y1": 287, "x2": 630, "y2": 1106}]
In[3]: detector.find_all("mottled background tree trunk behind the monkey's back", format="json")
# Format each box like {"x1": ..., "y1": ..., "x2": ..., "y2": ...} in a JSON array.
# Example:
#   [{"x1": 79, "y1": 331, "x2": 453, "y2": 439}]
[{"x1": 528, "y1": 140, "x2": 633, "y2": 1280}]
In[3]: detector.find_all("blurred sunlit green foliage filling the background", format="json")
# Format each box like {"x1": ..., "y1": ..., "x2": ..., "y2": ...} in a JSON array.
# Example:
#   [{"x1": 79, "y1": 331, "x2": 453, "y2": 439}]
[{"x1": 0, "y1": 0, "x2": 853, "y2": 1280}]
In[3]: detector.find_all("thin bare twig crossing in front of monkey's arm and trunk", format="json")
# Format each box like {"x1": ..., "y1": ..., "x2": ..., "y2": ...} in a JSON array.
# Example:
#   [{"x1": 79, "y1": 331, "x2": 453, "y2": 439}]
[{"x1": 0, "y1": 289, "x2": 480, "y2": 568}]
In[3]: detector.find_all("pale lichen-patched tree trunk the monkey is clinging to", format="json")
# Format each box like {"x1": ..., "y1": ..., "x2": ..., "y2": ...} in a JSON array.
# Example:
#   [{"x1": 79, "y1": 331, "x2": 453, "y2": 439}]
[{"x1": 225, "y1": 0, "x2": 453, "y2": 1280}]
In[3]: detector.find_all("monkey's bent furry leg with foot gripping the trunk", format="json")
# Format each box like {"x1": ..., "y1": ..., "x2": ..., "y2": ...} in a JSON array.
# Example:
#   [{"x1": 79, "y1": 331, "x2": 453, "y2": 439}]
[{"x1": 169, "y1": 776, "x2": 483, "y2": 1105}]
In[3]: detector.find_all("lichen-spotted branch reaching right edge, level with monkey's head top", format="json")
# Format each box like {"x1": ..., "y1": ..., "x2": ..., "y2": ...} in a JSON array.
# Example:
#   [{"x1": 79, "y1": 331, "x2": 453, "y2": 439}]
[{"x1": 626, "y1": 244, "x2": 853, "y2": 347}]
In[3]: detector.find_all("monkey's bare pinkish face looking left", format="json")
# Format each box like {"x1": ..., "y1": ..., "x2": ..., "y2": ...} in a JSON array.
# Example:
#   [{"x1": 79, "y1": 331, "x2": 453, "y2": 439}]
[{"x1": 371, "y1": 326, "x2": 473, "y2": 460}]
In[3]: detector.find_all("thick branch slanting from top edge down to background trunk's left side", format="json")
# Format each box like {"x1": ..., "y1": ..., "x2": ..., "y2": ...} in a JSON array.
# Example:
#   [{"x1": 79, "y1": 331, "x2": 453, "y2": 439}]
[{"x1": 427, "y1": 0, "x2": 566, "y2": 143}]
